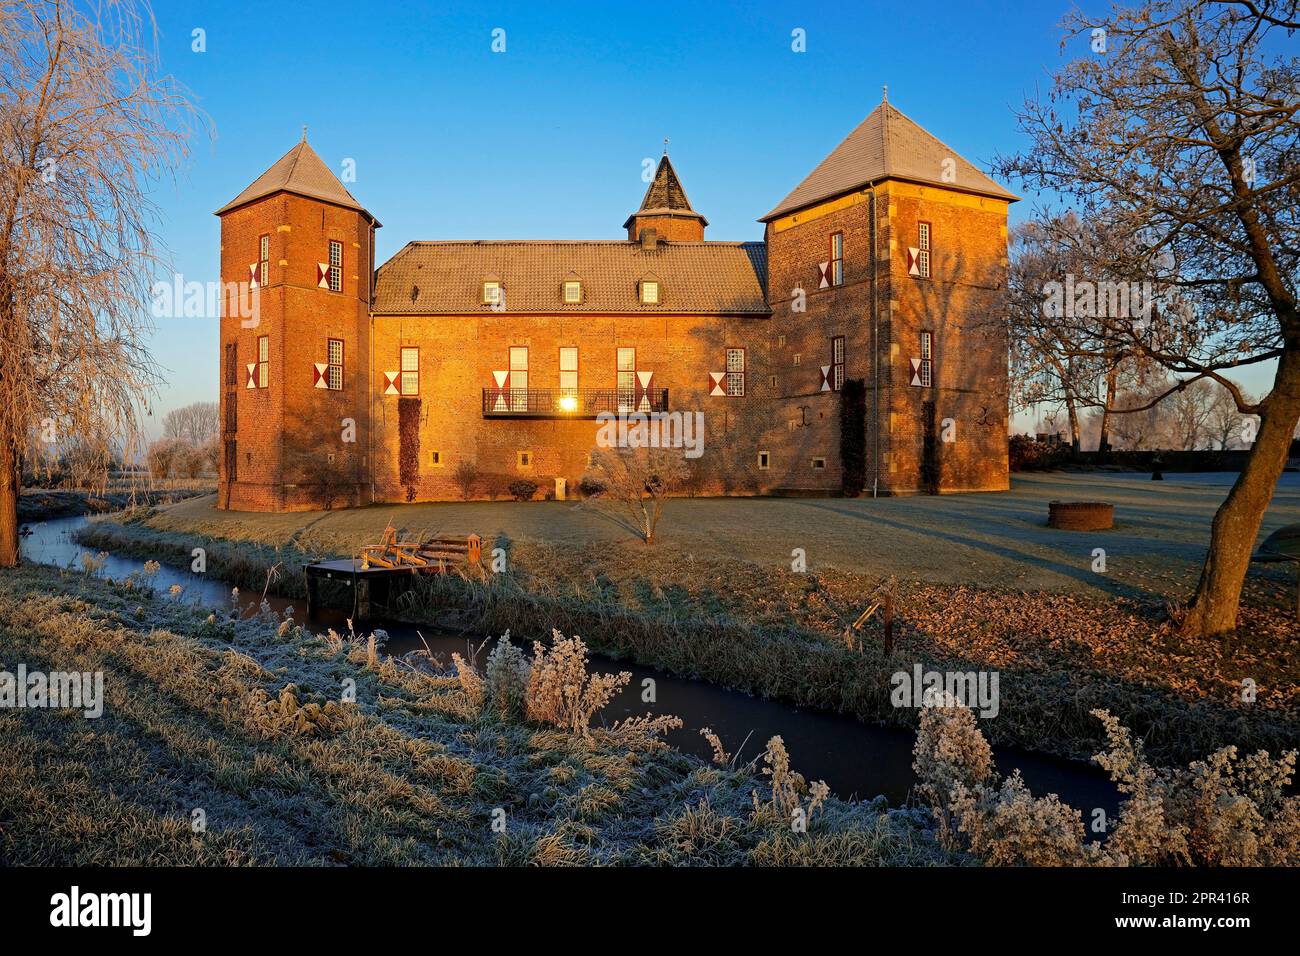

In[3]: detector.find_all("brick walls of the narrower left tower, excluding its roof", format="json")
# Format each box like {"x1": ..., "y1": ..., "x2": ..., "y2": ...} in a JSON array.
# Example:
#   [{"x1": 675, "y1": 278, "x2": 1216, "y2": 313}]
[{"x1": 218, "y1": 193, "x2": 373, "y2": 510}]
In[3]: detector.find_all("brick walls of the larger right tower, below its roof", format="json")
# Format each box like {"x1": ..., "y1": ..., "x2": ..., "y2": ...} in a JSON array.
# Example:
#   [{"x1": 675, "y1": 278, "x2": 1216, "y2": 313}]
[{"x1": 767, "y1": 182, "x2": 1008, "y2": 494}]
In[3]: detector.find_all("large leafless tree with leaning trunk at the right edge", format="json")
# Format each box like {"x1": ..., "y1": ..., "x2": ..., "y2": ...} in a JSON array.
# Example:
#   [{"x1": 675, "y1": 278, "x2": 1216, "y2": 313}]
[{"x1": 997, "y1": 0, "x2": 1300, "y2": 633}]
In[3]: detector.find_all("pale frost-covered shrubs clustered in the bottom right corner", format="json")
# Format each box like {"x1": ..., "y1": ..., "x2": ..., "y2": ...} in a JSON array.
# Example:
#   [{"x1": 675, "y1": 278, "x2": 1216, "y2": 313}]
[{"x1": 914, "y1": 706, "x2": 1300, "y2": 866}]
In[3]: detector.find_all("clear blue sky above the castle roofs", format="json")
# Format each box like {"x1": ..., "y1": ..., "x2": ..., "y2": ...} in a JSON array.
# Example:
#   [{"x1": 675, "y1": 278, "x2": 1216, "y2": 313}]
[{"x1": 142, "y1": 0, "x2": 1216, "y2": 431}]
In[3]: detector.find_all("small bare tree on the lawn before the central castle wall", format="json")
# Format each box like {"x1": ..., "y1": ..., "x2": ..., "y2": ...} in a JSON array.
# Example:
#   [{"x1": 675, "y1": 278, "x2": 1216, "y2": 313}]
[{"x1": 586, "y1": 447, "x2": 689, "y2": 545}]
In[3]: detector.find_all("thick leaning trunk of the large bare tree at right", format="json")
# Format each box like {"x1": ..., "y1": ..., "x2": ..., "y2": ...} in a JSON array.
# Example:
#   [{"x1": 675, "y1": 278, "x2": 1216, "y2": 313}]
[{"x1": 1183, "y1": 351, "x2": 1300, "y2": 636}]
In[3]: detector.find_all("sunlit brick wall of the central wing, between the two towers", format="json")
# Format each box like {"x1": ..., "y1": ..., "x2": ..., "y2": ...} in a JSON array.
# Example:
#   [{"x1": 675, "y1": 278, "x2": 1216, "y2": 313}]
[{"x1": 373, "y1": 312, "x2": 770, "y2": 501}]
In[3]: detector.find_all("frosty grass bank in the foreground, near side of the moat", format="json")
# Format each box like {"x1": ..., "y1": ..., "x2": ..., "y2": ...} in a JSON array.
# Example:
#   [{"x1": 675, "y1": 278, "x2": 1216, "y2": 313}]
[{"x1": 0, "y1": 567, "x2": 951, "y2": 865}]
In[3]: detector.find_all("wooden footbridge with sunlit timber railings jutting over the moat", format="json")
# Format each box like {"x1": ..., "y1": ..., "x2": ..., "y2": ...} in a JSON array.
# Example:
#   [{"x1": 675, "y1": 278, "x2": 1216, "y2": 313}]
[{"x1": 303, "y1": 525, "x2": 482, "y2": 622}]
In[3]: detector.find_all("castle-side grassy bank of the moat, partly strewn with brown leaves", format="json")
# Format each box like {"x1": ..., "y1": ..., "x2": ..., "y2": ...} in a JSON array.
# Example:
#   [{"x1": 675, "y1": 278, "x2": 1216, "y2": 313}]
[{"x1": 73, "y1": 514, "x2": 1300, "y2": 763}]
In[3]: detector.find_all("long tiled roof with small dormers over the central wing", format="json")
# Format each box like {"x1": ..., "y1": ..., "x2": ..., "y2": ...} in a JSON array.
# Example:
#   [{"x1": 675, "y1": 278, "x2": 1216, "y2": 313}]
[{"x1": 372, "y1": 239, "x2": 770, "y2": 316}]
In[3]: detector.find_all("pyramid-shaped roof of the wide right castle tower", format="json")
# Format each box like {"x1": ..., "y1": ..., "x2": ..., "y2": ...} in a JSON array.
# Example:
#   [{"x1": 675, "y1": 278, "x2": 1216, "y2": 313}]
[{"x1": 759, "y1": 103, "x2": 1019, "y2": 222}]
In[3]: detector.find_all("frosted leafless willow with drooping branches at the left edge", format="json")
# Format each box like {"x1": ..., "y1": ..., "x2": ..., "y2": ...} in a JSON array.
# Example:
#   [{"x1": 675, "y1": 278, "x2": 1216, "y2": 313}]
[{"x1": 0, "y1": 0, "x2": 195, "y2": 567}]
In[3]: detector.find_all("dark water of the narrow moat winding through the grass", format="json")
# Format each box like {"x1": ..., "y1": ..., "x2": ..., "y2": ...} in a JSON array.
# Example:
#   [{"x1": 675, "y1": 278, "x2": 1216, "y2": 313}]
[{"x1": 22, "y1": 518, "x2": 1118, "y2": 823}]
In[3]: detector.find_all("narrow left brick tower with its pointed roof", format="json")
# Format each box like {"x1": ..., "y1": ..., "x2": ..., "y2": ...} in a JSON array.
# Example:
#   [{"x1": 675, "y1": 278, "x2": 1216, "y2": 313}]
[{"x1": 216, "y1": 134, "x2": 380, "y2": 511}]
